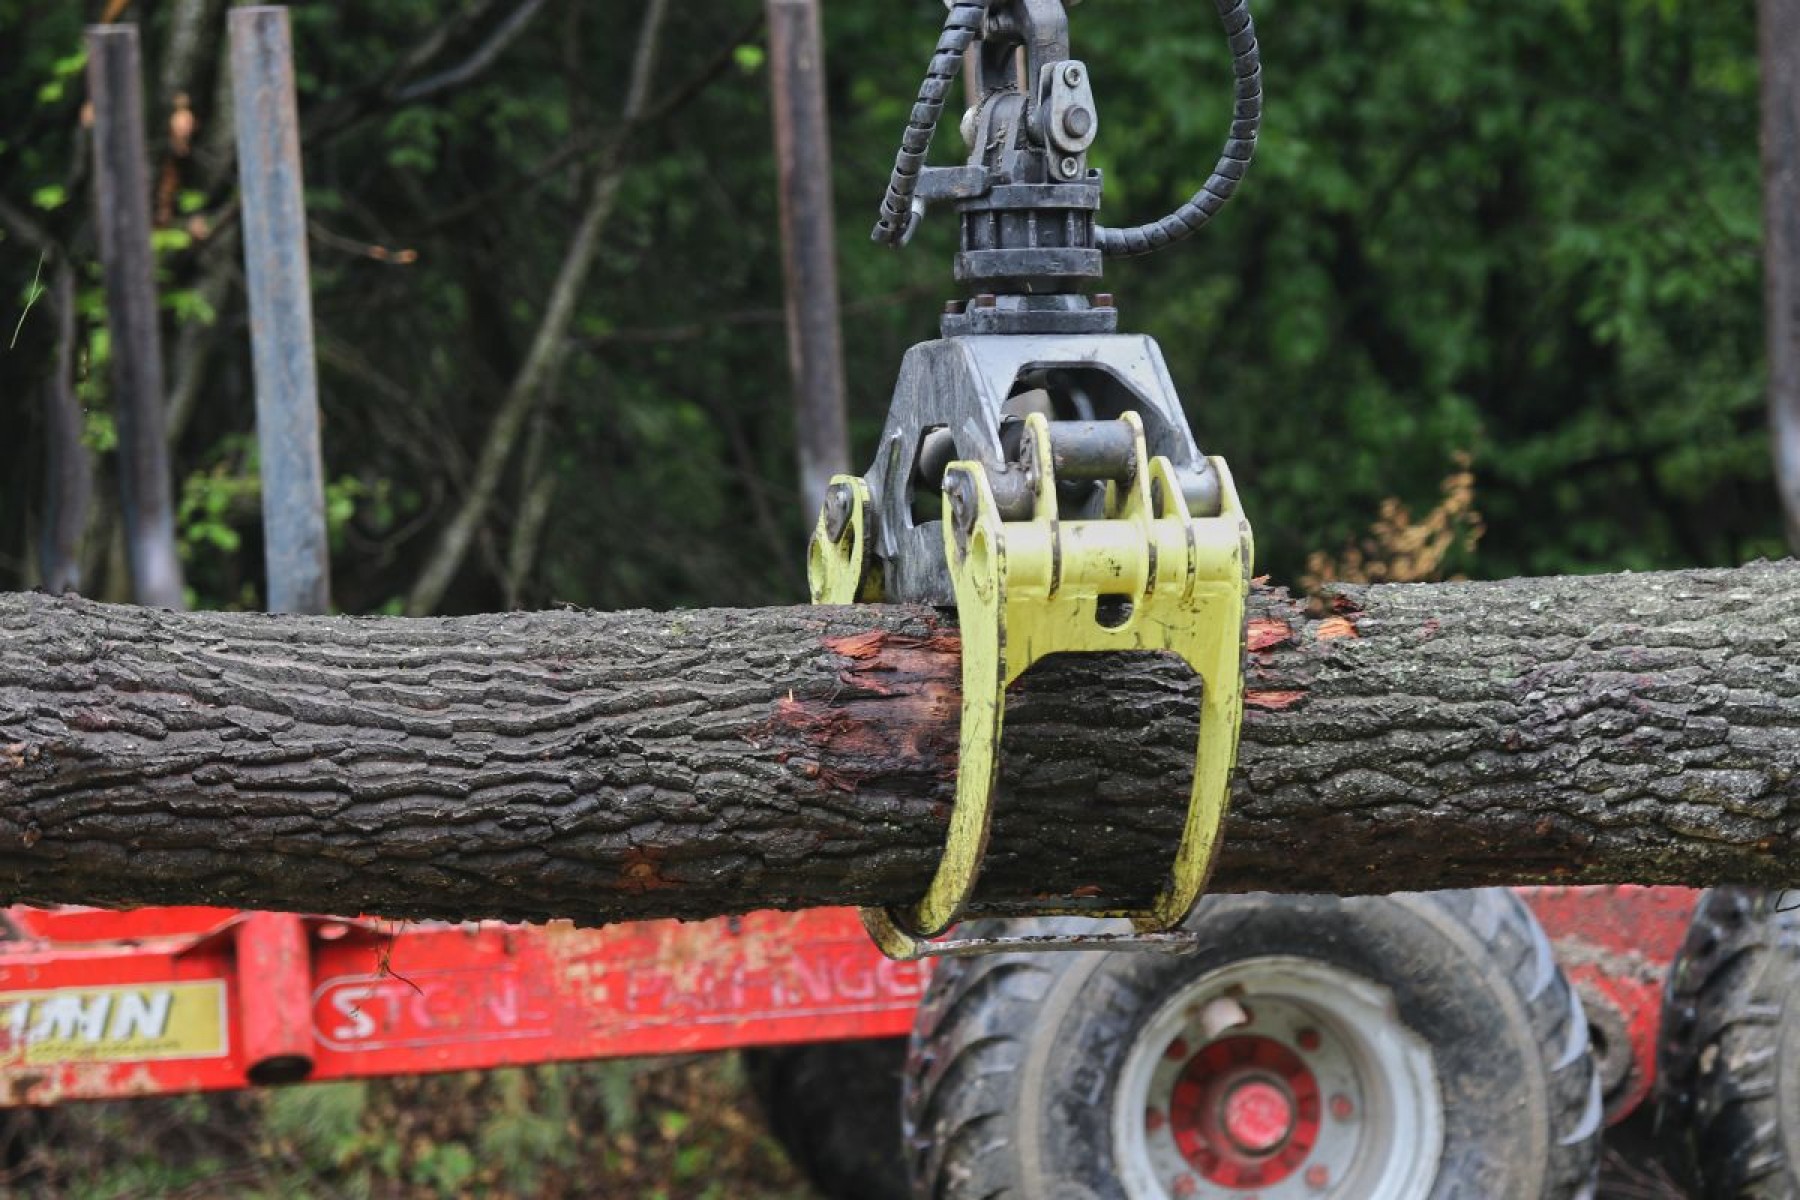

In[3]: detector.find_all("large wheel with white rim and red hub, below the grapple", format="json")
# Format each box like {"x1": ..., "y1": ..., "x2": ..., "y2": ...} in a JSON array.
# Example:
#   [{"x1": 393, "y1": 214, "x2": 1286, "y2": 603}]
[{"x1": 904, "y1": 889, "x2": 1602, "y2": 1200}]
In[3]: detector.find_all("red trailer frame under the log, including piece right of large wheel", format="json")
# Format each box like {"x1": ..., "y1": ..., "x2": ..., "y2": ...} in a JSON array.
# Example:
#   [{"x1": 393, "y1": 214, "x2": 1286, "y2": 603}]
[{"x1": 0, "y1": 887, "x2": 1696, "y2": 1121}]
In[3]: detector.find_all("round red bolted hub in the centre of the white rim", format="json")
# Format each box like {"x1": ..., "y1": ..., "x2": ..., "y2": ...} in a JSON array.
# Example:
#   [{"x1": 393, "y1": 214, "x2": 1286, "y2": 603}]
[{"x1": 1168, "y1": 1036, "x2": 1321, "y2": 1187}]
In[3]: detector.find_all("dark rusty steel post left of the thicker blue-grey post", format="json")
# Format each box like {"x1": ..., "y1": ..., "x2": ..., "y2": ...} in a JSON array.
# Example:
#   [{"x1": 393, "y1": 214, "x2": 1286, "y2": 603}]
[{"x1": 86, "y1": 25, "x2": 184, "y2": 608}]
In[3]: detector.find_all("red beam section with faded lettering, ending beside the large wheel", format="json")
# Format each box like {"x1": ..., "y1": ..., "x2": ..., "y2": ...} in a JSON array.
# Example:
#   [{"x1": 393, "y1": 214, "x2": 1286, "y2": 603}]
[{"x1": 313, "y1": 910, "x2": 925, "y2": 1078}]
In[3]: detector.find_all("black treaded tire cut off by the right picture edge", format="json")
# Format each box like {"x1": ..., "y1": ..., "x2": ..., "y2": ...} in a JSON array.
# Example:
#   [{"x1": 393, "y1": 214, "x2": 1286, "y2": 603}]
[{"x1": 1658, "y1": 887, "x2": 1800, "y2": 1200}]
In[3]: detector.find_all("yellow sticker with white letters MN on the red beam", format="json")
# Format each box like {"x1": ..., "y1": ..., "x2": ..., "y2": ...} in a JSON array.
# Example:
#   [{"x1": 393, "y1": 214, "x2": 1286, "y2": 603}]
[{"x1": 0, "y1": 979, "x2": 227, "y2": 1067}]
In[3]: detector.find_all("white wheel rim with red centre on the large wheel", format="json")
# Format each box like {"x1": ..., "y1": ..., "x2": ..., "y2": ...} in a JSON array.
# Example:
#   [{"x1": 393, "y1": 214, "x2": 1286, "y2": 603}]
[{"x1": 1112, "y1": 955, "x2": 1444, "y2": 1200}]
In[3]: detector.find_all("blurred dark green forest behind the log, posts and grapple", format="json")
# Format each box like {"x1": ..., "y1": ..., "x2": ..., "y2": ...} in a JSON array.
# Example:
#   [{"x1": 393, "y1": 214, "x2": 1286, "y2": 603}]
[{"x1": 0, "y1": 0, "x2": 1782, "y2": 1196}]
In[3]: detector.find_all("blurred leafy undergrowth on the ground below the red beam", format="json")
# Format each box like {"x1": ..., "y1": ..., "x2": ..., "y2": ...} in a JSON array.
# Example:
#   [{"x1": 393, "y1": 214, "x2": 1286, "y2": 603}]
[{"x1": 7, "y1": 1054, "x2": 812, "y2": 1200}]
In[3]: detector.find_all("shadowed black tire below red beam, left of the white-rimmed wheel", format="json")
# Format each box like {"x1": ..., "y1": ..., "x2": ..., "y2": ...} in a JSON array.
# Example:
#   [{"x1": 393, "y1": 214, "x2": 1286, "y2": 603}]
[{"x1": 743, "y1": 1038, "x2": 909, "y2": 1200}]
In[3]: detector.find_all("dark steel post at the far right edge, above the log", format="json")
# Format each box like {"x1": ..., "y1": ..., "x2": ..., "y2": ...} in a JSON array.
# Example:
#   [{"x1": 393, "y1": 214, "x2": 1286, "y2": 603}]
[{"x1": 1757, "y1": 0, "x2": 1800, "y2": 554}]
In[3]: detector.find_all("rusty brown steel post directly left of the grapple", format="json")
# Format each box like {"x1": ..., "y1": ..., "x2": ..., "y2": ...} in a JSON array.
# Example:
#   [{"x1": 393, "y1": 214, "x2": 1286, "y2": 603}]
[{"x1": 767, "y1": 0, "x2": 850, "y2": 522}]
